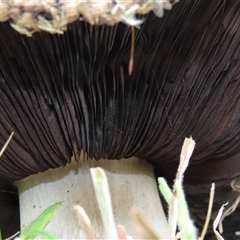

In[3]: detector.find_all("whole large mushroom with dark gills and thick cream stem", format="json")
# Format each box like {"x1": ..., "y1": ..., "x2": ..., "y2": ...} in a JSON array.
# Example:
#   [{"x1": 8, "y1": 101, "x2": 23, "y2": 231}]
[{"x1": 0, "y1": 0, "x2": 240, "y2": 238}]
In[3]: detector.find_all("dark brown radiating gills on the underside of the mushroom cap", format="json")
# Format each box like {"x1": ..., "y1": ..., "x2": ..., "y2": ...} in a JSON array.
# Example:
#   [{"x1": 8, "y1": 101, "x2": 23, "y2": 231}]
[{"x1": 0, "y1": 1, "x2": 240, "y2": 181}]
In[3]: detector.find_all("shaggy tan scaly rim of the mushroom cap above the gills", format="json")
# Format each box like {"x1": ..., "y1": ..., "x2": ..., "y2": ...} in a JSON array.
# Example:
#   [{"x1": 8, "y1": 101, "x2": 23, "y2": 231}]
[{"x1": 0, "y1": 0, "x2": 173, "y2": 36}]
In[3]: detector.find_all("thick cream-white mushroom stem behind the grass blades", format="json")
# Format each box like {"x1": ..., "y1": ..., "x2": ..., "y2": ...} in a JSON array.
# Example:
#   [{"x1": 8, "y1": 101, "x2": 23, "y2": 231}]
[{"x1": 16, "y1": 158, "x2": 168, "y2": 239}]
